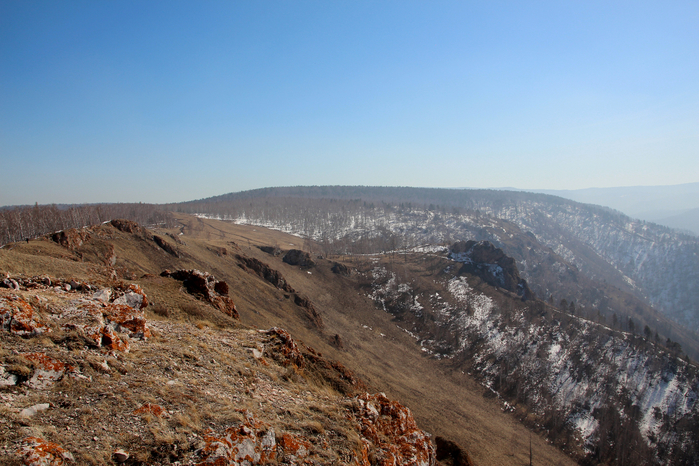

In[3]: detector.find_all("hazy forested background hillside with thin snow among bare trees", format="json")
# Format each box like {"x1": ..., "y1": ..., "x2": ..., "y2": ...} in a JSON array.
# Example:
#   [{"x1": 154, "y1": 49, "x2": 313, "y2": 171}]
[{"x1": 178, "y1": 187, "x2": 699, "y2": 358}]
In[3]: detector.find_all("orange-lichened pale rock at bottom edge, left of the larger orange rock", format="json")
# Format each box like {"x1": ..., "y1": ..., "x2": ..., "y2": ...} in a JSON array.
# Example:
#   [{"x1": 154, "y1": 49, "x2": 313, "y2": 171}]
[{"x1": 197, "y1": 412, "x2": 277, "y2": 466}]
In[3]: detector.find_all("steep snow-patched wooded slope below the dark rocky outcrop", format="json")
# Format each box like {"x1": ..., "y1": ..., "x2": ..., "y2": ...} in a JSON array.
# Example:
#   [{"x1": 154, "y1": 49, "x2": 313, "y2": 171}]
[{"x1": 365, "y1": 244, "x2": 699, "y2": 465}]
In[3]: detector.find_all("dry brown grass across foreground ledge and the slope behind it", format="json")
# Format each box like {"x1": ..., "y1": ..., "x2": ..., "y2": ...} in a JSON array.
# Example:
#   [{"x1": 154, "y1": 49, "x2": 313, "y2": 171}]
[{"x1": 0, "y1": 214, "x2": 572, "y2": 466}]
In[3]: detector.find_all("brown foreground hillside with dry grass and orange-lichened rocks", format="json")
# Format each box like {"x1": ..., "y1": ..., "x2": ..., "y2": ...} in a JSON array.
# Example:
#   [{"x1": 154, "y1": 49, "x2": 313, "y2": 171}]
[{"x1": 0, "y1": 216, "x2": 572, "y2": 465}]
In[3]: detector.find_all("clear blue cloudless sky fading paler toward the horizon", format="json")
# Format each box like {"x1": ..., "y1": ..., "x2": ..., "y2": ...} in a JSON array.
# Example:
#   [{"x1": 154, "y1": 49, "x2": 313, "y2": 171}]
[{"x1": 0, "y1": 0, "x2": 699, "y2": 205}]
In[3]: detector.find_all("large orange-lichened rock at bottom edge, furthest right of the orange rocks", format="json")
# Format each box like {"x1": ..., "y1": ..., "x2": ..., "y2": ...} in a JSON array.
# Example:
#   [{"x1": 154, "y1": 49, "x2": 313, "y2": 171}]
[{"x1": 354, "y1": 393, "x2": 436, "y2": 466}]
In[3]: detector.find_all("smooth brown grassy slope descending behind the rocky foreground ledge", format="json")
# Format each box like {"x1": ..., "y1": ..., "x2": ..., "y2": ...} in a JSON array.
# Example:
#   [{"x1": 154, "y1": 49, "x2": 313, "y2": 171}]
[{"x1": 0, "y1": 215, "x2": 574, "y2": 466}]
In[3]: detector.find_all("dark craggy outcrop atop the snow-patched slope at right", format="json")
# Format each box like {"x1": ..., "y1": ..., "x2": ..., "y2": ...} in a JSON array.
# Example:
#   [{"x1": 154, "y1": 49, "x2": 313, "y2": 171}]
[{"x1": 449, "y1": 240, "x2": 534, "y2": 299}]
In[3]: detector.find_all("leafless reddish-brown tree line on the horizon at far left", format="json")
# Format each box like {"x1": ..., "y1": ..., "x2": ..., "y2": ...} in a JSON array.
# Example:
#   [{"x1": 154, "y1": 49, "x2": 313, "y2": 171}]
[{"x1": 0, "y1": 203, "x2": 175, "y2": 244}]
